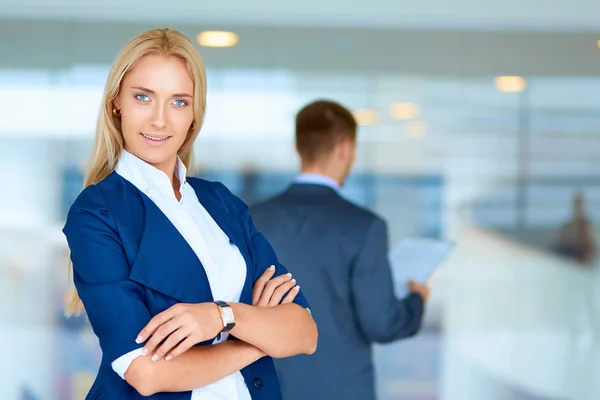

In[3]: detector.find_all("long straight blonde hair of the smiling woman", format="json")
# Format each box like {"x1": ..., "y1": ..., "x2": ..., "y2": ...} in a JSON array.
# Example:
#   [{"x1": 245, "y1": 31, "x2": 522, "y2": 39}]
[{"x1": 66, "y1": 29, "x2": 206, "y2": 316}]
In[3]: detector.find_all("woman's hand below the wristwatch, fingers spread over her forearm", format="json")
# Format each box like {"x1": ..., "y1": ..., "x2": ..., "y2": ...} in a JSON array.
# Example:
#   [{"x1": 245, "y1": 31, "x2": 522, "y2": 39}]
[{"x1": 136, "y1": 303, "x2": 223, "y2": 361}]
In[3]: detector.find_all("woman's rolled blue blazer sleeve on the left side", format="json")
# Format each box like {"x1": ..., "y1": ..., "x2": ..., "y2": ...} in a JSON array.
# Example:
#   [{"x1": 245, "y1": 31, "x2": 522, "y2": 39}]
[{"x1": 63, "y1": 186, "x2": 151, "y2": 361}]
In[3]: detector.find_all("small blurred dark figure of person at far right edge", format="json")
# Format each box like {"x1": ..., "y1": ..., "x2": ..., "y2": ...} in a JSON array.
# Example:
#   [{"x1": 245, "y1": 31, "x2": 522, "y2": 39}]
[{"x1": 556, "y1": 192, "x2": 598, "y2": 266}]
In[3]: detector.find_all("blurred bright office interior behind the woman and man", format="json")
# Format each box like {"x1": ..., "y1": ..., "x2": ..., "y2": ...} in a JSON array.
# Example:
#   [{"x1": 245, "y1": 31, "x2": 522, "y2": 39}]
[{"x1": 0, "y1": 0, "x2": 600, "y2": 400}]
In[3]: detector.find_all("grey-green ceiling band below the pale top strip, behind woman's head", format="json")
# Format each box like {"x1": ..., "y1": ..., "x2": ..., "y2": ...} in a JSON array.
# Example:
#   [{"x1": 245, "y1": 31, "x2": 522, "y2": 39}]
[{"x1": 0, "y1": 18, "x2": 600, "y2": 76}]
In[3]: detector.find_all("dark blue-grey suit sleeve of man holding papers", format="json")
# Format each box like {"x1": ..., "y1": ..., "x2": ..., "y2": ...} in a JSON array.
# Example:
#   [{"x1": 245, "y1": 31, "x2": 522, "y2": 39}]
[{"x1": 350, "y1": 218, "x2": 424, "y2": 343}]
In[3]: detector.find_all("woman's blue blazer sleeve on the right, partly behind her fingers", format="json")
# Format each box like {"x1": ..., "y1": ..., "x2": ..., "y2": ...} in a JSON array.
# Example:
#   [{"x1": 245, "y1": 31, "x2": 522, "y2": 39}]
[{"x1": 221, "y1": 184, "x2": 310, "y2": 310}]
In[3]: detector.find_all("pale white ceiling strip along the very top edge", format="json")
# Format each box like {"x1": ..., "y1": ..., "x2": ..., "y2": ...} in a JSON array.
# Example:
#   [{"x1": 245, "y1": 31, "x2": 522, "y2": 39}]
[{"x1": 0, "y1": 0, "x2": 600, "y2": 31}]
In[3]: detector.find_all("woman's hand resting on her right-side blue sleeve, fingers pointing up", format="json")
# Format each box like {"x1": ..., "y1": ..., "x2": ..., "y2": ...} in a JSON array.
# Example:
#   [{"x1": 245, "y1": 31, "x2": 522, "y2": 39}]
[{"x1": 252, "y1": 265, "x2": 300, "y2": 307}]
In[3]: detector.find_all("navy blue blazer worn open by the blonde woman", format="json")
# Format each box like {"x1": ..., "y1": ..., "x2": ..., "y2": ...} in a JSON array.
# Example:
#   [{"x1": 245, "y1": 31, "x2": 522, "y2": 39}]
[{"x1": 63, "y1": 172, "x2": 308, "y2": 400}]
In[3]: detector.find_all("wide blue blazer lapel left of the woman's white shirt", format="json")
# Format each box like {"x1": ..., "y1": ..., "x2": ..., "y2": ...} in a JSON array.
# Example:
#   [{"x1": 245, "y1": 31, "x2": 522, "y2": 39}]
[{"x1": 129, "y1": 195, "x2": 213, "y2": 303}]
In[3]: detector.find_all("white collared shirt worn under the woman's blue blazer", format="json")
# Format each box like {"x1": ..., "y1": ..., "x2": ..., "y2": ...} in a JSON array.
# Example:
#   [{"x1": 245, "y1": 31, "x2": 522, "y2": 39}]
[{"x1": 112, "y1": 150, "x2": 251, "y2": 400}]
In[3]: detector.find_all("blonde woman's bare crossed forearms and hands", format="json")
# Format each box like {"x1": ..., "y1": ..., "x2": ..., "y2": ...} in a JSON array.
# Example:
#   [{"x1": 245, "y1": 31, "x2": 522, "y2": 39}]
[{"x1": 125, "y1": 269, "x2": 316, "y2": 395}]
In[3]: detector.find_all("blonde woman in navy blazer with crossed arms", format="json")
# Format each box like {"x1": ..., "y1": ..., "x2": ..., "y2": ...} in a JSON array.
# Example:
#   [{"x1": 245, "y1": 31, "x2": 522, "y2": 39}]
[{"x1": 63, "y1": 29, "x2": 317, "y2": 400}]
